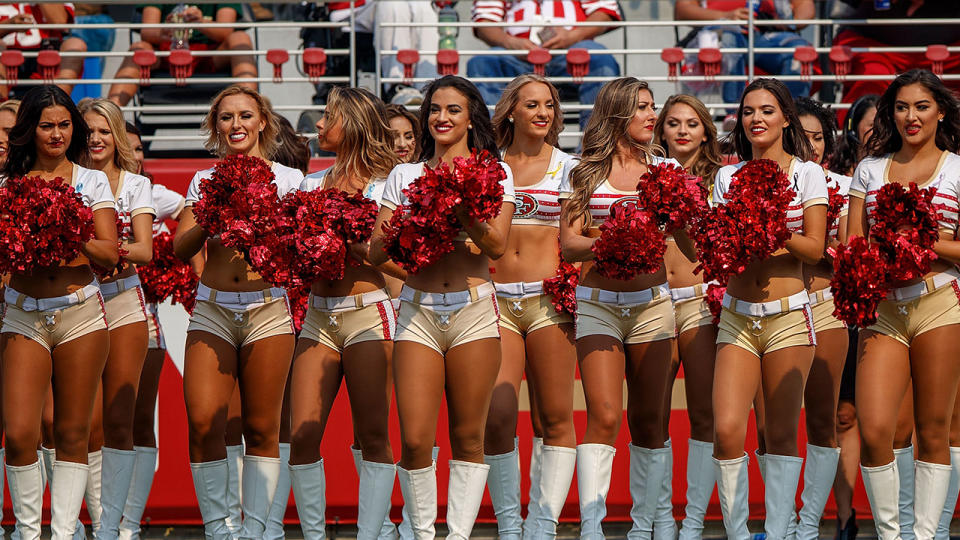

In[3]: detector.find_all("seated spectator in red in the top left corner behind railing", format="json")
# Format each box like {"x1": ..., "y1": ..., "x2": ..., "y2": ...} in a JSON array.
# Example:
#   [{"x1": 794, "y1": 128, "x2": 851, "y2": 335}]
[{"x1": 0, "y1": 2, "x2": 87, "y2": 99}]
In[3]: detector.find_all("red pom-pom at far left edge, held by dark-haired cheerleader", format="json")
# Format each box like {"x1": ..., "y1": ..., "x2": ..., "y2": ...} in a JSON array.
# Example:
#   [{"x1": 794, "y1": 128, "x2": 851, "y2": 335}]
[{"x1": 0, "y1": 177, "x2": 94, "y2": 274}]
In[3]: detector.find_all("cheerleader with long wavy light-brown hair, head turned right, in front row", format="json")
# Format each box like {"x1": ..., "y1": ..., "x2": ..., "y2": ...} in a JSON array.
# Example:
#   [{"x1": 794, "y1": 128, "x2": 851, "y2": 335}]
[{"x1": 564, "y1": 77, "x2": 689, "y2": 539}]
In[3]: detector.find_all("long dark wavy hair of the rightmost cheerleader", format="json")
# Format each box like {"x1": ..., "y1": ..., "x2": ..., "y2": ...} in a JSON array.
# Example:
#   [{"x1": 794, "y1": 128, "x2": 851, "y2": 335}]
[{"x1": 866, "y1": 69, "x2": 960, "y2": 157}]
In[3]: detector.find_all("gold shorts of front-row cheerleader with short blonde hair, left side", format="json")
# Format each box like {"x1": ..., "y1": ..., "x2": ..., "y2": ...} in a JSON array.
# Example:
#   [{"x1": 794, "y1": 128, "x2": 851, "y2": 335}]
[{"x1": 187, "y1": 283, "x2": 294, "y2": 348}]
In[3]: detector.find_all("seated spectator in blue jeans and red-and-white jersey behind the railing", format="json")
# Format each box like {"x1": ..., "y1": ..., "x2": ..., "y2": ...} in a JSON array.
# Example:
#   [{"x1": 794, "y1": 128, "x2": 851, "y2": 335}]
[{"x1": 467, "y1": 0, "x2": 623, "y2": 129}]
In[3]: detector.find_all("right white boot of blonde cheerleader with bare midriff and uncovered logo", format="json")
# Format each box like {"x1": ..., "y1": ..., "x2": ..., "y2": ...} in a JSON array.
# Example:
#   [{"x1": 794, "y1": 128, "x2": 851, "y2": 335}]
[{"x1": 523, "y1": 445, "x2": 577, "y2": 540}]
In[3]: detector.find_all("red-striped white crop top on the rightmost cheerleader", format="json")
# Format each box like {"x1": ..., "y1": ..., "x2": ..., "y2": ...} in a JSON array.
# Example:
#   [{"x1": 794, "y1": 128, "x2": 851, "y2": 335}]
[{"x1": 850, "y1": 150, "x2": 960, "y2": 236}]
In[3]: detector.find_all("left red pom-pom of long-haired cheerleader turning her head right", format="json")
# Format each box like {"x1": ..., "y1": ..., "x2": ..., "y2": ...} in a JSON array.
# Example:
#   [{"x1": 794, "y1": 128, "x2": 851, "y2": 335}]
[{"x1": 592, "y1": 206, "x2": 667, "y2": 280}]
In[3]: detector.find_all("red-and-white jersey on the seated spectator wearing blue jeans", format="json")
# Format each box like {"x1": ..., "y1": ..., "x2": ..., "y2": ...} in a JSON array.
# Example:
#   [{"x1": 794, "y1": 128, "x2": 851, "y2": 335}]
[{"x1": 473, "y1": 0, "x2": 622, "y2": 39}]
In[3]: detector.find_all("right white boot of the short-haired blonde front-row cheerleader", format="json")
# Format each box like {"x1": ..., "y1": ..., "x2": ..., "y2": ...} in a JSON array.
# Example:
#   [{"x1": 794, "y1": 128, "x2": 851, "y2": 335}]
[{"x1": 237, "y1": 455, "x2": 280, "y2": 540}]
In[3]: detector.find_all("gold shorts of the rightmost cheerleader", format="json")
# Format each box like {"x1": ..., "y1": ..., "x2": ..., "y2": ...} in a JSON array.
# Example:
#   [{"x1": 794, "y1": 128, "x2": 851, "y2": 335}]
[{"x1": 866, "y1": 272, "x2": 960, "y2": 347}]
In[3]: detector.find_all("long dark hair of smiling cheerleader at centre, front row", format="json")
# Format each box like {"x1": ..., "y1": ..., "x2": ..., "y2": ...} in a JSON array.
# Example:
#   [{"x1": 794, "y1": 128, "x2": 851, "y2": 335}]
[{"x1": 419, "y1": 75, "x2": 500, "y2": 161}]
